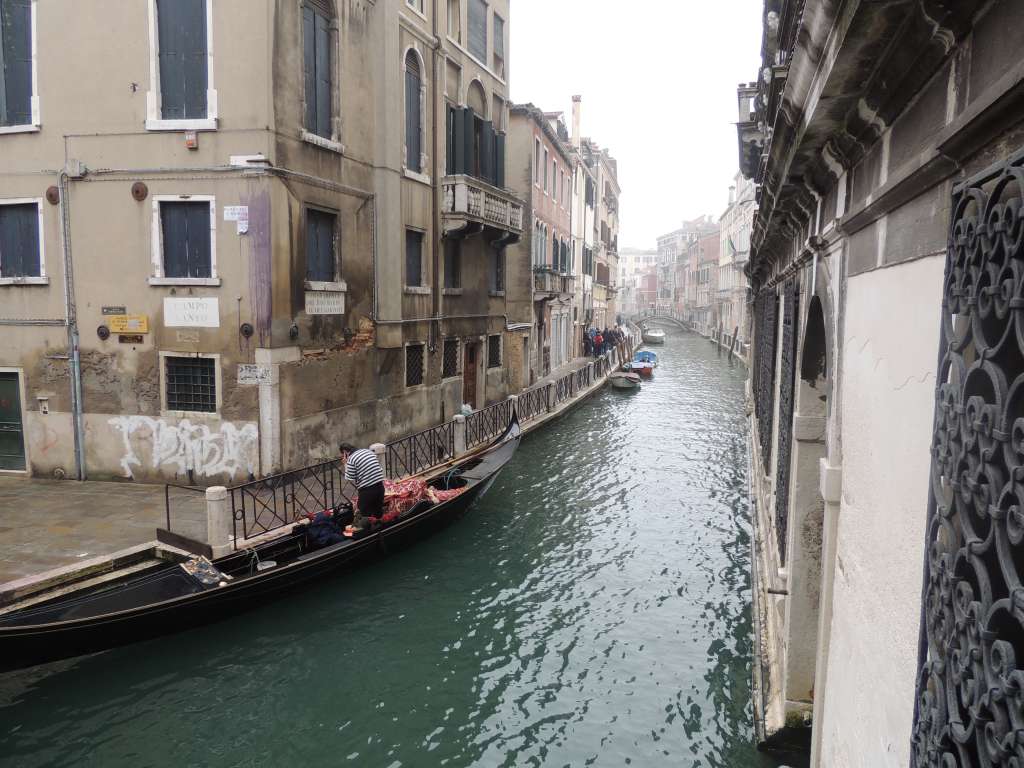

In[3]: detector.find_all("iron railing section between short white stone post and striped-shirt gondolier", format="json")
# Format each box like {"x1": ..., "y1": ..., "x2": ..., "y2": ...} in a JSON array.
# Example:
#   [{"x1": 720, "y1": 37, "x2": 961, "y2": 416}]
[{"x1": 230, "y1": 459, "x2": 355, "y2": 541}]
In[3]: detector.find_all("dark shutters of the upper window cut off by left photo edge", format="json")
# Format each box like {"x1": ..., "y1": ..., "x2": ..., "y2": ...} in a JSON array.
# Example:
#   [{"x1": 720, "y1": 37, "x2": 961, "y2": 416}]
[{"x1": 0, "y1": 0, "x2": 32, "y2": 126}]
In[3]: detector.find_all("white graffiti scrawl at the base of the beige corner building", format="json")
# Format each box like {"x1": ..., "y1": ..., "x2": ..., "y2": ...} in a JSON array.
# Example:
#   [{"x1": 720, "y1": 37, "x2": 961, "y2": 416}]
[{"x1": 109, "y1": 416, "x2": 259, "y2": 477}]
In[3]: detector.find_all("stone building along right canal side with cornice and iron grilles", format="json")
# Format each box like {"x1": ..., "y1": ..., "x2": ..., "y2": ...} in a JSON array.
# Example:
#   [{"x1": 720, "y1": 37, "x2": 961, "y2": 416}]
[{"x1": 738, "y1": 0, "x2": 1024, "y2": 768}]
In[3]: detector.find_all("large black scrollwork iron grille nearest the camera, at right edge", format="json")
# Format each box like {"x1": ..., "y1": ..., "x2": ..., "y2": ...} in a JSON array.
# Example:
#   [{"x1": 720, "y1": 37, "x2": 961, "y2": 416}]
[{"x1": 911, "y1": 155, "x2": 1024, "y2": 768}]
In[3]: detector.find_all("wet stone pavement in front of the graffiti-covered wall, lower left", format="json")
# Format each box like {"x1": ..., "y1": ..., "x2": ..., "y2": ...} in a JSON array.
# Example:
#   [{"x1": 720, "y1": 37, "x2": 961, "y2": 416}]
[{"x1": 0, "y1": 476, "x2": 180, "y2": 584}]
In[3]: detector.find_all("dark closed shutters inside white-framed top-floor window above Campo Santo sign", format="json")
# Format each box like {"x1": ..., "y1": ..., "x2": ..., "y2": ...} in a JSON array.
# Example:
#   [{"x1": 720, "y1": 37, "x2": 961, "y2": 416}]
[{"x1": 157, "y1": 0, "x2": 208, "y2": 120}]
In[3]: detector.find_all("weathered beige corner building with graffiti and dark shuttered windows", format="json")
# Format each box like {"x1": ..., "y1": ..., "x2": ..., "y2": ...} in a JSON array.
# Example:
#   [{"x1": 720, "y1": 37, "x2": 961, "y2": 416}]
[{"x1": 0, "y1": 0, "x2": 532, "y2": 483}]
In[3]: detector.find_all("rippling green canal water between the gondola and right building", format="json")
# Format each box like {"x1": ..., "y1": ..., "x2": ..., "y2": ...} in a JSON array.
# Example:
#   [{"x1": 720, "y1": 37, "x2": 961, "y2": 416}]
[{"x1": 0, "y1": 333, "x2": 798, "y2": 768}]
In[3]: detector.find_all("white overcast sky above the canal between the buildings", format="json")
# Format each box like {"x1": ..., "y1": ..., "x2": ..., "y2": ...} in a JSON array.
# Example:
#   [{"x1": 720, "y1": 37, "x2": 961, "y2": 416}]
[{"x1": 509, "y1": 0, "x2": 762, "y2": 248}]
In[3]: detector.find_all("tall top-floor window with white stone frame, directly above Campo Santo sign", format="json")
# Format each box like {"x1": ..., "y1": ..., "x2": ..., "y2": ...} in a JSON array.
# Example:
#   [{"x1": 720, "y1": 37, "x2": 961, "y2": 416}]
[{"x1": 146, "y1": 0, "x2": 217, "y2": 130}]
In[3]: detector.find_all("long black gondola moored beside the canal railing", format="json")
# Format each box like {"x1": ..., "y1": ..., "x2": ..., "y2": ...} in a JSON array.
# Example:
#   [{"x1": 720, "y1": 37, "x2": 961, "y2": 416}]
[{"x1": 0, "y1": 417, "x2": 521, "y2": 672}]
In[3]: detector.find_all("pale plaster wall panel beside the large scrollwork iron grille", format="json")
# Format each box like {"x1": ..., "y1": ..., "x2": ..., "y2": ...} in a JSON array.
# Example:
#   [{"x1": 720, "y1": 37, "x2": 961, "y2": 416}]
[{"x1": 816, "y1": 257, "x2": 944, "y2": 768}]
